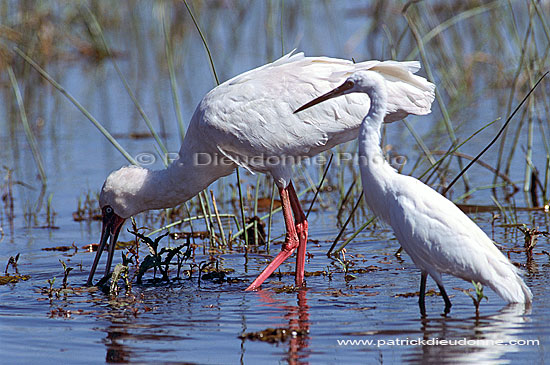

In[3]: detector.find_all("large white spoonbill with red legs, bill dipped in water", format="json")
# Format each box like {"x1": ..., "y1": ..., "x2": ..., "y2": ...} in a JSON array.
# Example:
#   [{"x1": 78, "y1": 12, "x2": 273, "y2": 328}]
[{"x1": 88, "y1": 53, "x2": 440, "y2": 290}]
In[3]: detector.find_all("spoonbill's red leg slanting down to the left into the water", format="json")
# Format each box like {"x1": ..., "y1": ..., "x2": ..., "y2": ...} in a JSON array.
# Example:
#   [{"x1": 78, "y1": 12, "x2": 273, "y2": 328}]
[{"x1": 246, "y1": 185, "x2": 300, "y2": 291}]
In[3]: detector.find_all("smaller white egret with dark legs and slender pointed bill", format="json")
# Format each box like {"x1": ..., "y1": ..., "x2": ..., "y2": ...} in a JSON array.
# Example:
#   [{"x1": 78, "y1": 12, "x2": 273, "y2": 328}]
[{"x1": 295, "y1": 70, "x2": 533, "y2": 315}]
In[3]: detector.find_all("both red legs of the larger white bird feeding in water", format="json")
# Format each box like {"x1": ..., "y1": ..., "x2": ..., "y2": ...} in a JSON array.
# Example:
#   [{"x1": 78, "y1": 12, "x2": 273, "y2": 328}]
[{"x1": 246, "y1": 183, "x2": 307, "y2": 291}]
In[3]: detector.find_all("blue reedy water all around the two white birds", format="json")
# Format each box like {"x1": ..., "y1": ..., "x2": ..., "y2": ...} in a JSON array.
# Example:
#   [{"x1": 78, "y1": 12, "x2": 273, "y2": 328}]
[{"x1": 0, "y1": 1, "x2": 550, "y2": 364}]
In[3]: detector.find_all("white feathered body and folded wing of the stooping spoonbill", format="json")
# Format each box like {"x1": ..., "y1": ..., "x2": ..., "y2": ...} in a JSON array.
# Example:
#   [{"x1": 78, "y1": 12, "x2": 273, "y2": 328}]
[{"x1": 190, "y1": 53, "x2": 434, "y2": 186}]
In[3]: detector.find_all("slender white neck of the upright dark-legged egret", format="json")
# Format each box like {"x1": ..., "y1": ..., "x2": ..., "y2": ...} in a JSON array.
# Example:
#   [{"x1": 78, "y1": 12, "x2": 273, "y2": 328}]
[{"x1": 359, "y1": 86, "x2": 396, "y2": 221}]
